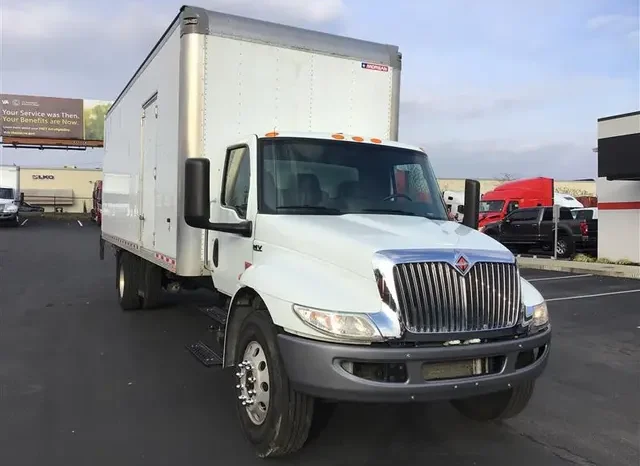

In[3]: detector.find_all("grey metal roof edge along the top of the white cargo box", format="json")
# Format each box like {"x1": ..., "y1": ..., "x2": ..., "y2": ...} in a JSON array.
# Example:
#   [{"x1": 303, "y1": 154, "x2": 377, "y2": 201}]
[{"x1": 107, "y1": 5, "x2": 402, "y2": 115}]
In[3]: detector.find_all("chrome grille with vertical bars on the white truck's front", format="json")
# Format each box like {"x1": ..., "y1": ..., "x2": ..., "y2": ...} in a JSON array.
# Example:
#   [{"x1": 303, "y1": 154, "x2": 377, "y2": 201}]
[{"x1": 393, "y1": 262, "x2": 520, "y2": 333}]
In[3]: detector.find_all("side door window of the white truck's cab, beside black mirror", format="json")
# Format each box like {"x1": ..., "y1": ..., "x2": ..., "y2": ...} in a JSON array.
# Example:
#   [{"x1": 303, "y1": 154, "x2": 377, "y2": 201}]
[{"x1": 221, "y1": 146, "x2": 251, "y2": 218}]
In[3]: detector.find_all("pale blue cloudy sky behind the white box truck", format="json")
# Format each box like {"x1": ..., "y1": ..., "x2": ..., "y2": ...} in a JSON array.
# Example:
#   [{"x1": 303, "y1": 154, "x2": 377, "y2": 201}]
[{"x1": 0, "y1": 0, "x2": 640, "y2": 180}]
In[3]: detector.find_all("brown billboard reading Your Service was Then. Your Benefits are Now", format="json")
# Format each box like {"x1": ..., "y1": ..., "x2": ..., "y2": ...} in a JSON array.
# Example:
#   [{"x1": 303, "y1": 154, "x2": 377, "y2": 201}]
[{"x1": 0, "y1": 94, "x2": 112, "y2": 141}]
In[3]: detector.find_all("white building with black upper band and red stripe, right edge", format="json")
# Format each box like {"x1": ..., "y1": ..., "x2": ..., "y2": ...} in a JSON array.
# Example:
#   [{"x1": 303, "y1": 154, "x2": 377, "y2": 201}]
[{"x1": 597, "y1": 111, "x2": 640, "y2": 263}]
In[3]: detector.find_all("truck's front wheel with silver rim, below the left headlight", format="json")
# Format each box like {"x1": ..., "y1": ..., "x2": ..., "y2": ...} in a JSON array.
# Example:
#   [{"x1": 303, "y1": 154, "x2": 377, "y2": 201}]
[{"x1": 236, "y1": 310, "x2": 314, "y2": 458}]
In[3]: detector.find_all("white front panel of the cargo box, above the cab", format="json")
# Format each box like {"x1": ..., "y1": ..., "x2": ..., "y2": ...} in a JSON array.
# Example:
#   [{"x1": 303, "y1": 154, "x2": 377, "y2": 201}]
[{"x1": 204, "y1": 36, "x2": 397, "y2": 221}]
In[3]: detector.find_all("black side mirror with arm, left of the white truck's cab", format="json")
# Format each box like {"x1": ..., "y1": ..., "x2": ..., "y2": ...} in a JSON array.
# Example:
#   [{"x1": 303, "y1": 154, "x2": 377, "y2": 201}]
[{"x1": 184, "y1": 157, "x2": 252, "y2": 237}]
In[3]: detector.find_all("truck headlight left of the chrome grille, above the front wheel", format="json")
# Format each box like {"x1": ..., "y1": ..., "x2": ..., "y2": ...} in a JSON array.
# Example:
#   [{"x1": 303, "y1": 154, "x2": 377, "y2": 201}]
[{"x1": 293, "y1": 304, "x2": 382, "y2": 341}]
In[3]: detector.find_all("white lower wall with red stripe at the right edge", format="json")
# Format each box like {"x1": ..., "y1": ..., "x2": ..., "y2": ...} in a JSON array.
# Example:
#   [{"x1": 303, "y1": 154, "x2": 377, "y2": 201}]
[{"x1": 598, "y1": 178, "x2": 640, "y2": 262}]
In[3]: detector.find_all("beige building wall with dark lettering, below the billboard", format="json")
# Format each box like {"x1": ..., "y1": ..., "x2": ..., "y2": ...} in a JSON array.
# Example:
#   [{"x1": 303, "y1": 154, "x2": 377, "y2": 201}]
[{"x1": 20, "y1": 167, "x2": 102, "y2": 213}]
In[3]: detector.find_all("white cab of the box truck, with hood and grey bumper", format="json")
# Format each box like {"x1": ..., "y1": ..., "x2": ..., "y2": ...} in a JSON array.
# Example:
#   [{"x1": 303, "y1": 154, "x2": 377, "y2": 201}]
[{"x1": 184, "y1": 133, "x2": 550, "y2": 456}]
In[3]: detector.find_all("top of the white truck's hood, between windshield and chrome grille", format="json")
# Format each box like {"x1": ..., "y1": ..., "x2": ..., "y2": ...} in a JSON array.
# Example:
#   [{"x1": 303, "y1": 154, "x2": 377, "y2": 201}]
[{"x1": 256, "y1": 214, "x2": 508, "y2": 279}]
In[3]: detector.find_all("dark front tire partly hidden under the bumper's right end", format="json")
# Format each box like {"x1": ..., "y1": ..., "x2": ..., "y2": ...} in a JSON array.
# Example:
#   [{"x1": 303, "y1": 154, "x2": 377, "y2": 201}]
[{"x1": 451, "y1": 381, "x2": 535, "y2": 422}]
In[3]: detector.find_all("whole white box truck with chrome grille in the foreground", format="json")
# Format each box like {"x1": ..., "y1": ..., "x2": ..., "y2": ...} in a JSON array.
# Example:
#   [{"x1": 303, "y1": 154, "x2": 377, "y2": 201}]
[{"x1": 100, "y1": 7, "x2": 551, "y2": 457}]
